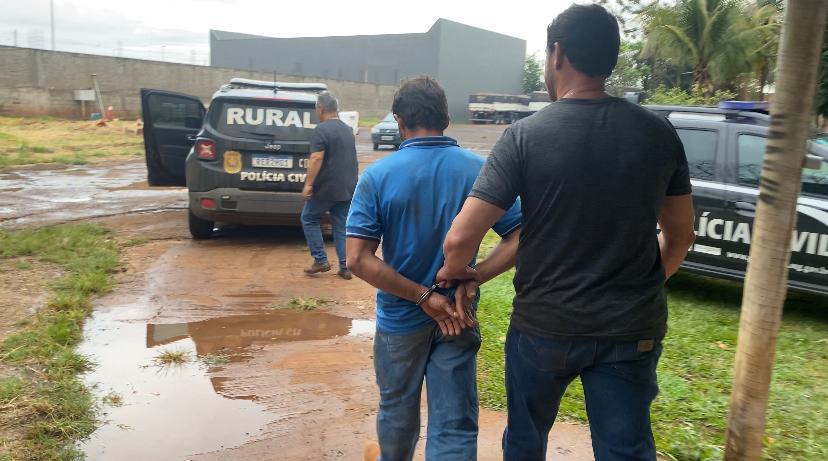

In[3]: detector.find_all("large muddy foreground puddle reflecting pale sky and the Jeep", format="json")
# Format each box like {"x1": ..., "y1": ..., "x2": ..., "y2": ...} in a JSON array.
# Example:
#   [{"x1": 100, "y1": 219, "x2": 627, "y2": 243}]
[{"x1": 80, "y1": 299, "x2": 374, "y2": 461}]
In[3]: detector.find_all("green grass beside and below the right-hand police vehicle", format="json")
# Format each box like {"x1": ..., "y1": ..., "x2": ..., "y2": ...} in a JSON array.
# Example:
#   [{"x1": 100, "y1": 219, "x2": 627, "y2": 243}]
[{"x1": 478, "y1": 235, "x2": 828, "y2": 461}]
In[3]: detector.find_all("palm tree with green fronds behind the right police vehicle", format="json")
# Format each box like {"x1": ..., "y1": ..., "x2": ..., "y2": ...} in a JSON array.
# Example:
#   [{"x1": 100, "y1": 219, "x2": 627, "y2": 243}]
[{"x1": 641, "y1": 0, "x2": 750, "y2": 93}]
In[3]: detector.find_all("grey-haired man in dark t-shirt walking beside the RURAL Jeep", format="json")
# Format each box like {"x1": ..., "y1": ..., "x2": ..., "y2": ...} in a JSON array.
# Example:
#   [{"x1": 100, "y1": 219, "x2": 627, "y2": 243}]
[{"x1": 302, "y1": 91, "x2": 359, "y2": 280}]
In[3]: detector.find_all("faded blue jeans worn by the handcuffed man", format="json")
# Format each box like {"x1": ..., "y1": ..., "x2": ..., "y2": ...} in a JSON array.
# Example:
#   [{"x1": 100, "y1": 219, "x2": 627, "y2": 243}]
[{"x1": 374, "y1": 324, "x2": 480, "y2": 461}]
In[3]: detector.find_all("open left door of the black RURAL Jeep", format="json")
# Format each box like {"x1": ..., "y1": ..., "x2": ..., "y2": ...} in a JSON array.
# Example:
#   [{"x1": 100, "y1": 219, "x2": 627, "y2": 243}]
[{"x1": 141, "y1": 88, "x2": 206, "y2": 186}]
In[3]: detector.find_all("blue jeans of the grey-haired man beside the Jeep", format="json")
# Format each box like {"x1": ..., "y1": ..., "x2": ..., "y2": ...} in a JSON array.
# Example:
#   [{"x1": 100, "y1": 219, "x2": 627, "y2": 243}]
[{"x1": 301, "y1": 199, "x2": 351, "y2": 269}]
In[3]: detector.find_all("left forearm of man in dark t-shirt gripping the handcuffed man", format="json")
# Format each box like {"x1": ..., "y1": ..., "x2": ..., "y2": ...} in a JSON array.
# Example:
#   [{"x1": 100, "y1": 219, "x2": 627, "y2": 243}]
[{"x1": 444, "y1": 197, "x2": 514, "y2": 282}]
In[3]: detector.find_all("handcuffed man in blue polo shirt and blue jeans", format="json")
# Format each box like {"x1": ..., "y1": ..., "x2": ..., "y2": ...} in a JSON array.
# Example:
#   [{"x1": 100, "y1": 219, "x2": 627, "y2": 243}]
[{"x1": 346, "y1": 76, "x2": 521, "y2": 461}]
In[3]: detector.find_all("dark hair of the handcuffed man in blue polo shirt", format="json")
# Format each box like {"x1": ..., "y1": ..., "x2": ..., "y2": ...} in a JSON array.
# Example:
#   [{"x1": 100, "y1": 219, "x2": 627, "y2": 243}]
[{"x1": 391, "y1": 75, "x2": 449, "y2": 131}]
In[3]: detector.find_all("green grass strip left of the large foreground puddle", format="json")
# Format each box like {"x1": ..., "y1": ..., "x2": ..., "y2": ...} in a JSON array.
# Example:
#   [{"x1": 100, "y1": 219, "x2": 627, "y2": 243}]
[{"x1": 0, "y1": 224, "x2": 118, "y2": 460}]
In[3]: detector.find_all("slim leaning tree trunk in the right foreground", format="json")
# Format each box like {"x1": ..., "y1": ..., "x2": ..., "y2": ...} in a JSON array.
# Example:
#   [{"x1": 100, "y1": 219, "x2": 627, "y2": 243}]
[{"x1": 724, "y1": 0, "x2": 828, "y2": 461}]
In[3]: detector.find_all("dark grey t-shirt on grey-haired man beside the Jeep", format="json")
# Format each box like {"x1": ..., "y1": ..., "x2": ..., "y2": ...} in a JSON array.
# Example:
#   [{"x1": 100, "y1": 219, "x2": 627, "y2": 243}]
[{"x1": 310, "y1": 119, "x2": 359, "y2": 202}]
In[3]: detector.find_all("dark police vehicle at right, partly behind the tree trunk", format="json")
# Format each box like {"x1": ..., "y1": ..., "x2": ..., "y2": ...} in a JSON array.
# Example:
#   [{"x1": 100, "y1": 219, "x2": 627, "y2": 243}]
[{"x1": 647, "y1": 102, "x2": 828, "y2": 295}]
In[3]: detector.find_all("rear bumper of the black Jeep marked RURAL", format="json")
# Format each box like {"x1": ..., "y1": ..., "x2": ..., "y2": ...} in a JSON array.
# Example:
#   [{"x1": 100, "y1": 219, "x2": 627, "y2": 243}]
[{"x1": 189, "y1": 188, "x2": 305, "y2": 225}]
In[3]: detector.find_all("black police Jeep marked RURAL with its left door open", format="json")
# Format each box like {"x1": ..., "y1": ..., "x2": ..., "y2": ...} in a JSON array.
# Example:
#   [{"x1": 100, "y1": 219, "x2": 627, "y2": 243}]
[{"x1": 141, "y1": 79, "x2": 326, "y2": 239}]
